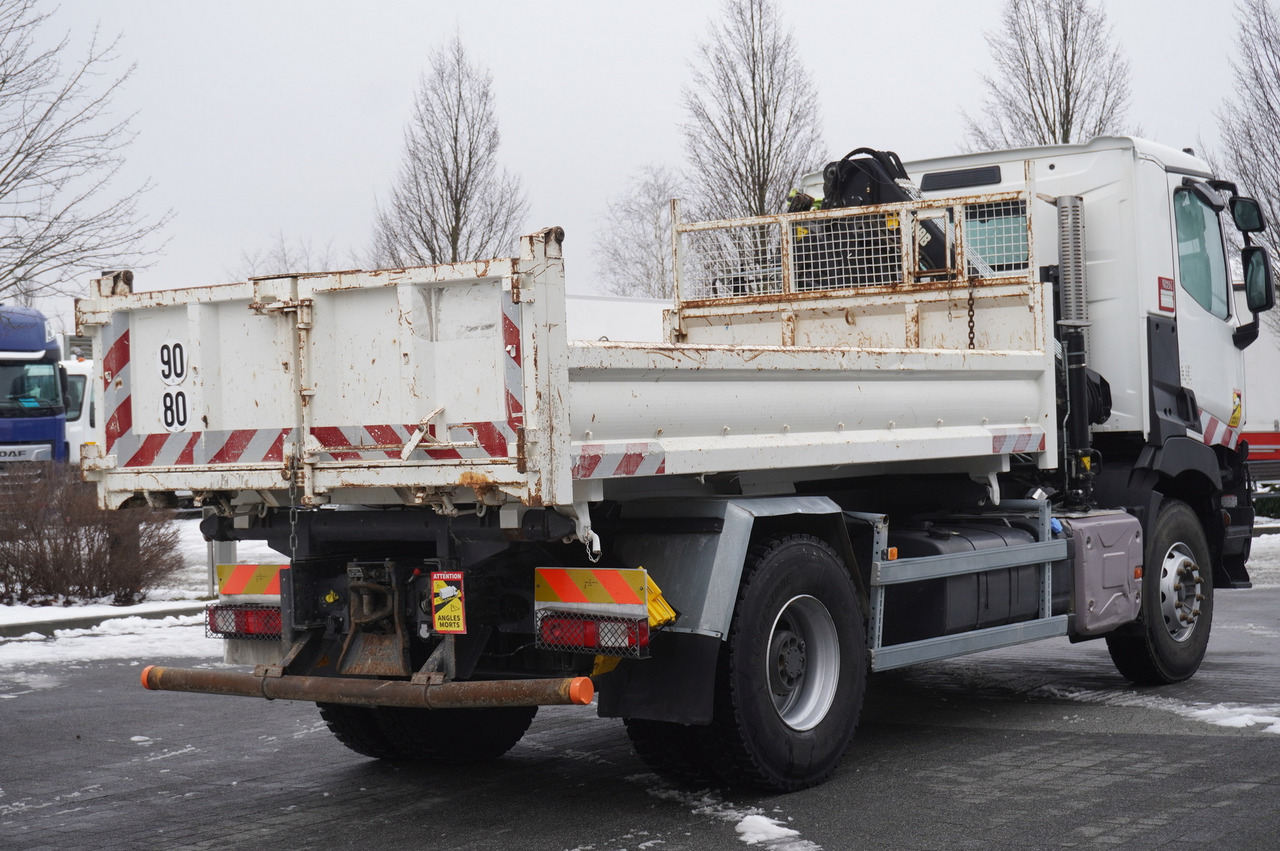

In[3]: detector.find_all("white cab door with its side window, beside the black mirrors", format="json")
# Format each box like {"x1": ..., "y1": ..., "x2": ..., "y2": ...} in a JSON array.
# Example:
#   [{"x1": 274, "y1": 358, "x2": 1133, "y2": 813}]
[{"x1": 1169, "y1": 181, "x2": 1244, "y2": 445}]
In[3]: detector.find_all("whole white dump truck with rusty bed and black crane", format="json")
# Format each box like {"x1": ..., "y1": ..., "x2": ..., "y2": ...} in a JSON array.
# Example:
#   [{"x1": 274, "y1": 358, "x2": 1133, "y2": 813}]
[{"x1": 78, "y1": 138, "x2": 1274, "y2": 790}]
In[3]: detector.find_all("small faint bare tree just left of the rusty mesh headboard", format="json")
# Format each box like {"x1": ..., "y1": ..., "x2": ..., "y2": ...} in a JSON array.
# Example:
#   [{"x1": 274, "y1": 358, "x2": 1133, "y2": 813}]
[{"x1": 595, "y1": 165, "x2": 680, "y2": 298}]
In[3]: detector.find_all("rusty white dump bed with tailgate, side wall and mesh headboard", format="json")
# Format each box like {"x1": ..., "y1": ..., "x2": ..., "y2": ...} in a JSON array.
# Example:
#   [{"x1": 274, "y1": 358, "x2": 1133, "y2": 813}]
[{"x1": 78, "y1": 195, "x2": 1056, "y2": 511}]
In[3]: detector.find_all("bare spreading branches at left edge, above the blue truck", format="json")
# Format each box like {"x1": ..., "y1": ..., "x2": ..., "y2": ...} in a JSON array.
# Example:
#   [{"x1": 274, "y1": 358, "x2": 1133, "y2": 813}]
[{"x1": 0, "y1": 0, "x2": 169, "y2": 299}]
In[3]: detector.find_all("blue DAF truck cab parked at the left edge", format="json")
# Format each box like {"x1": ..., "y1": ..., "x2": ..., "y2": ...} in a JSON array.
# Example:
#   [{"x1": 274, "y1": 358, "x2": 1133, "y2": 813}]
[{"x1": 0, "y1": 305, "x2": 67, "y2": 472}]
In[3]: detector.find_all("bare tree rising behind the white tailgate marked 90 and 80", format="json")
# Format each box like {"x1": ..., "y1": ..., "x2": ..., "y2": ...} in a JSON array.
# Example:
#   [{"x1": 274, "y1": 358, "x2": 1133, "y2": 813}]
[{"x1": 372, "y1": 36, "x2": 529, "y2": 266}]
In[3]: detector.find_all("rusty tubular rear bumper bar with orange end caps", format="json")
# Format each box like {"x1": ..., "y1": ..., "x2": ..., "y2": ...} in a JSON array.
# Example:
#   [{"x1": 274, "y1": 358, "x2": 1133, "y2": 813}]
[{"x1": 142, "y1": 665, "x2": 595, "y2": 709}]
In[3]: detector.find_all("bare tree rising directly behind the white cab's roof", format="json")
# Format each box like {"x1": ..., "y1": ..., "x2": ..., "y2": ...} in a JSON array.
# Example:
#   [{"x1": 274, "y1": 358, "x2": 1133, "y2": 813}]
[{"x1": 964, "y1": 0, "x2": 1129, "y2": 148}]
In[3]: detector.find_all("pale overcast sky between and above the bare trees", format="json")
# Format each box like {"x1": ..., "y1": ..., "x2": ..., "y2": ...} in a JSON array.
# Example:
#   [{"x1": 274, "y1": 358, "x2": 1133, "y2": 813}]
[{"x1": 51, "y1": 0, "x2": 1235, "y2": 332}]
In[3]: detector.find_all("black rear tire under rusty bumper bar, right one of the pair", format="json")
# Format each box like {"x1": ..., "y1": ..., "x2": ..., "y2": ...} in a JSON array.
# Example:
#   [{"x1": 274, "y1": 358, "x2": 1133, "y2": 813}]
[{"x1": 378, "y1": 706, "x2": 538, "y2": 765}]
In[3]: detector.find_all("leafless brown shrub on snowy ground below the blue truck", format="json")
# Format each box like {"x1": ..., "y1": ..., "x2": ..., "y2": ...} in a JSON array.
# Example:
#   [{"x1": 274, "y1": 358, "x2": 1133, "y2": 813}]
[{"x1": 0, "y1": 465, "x2": 183, "y2": 605}]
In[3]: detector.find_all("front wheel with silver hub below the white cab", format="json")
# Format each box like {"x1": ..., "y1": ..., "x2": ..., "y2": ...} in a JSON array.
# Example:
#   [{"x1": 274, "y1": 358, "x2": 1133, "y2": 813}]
[{"x1": 1107, "y1": 499, "x2": 1213, "y2": 686}]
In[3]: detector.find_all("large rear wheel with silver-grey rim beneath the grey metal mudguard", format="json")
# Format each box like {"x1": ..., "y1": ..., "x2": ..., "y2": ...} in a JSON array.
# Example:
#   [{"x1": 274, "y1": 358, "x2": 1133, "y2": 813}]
[{"x1": 710, "y1": 535, "x2": 867, "y2": 791}]
